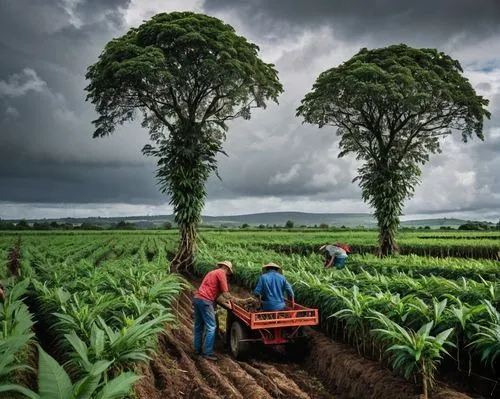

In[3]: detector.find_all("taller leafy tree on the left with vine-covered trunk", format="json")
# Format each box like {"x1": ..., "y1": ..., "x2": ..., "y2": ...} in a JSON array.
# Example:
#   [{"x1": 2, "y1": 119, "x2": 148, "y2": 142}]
[{"x1": 86, "y1": 12, "x2": 283, "y2": 271}]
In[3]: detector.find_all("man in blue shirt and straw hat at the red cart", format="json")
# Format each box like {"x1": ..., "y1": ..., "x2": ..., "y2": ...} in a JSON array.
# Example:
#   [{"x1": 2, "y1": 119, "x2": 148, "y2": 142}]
[{"x1": 254, "y1": 263, "x2": 294, "y2": 311}]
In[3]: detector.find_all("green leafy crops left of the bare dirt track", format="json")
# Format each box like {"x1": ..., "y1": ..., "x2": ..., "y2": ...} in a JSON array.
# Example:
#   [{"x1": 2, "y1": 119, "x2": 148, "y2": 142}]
[{"x1": 0, "y1": 234, "x2": 185, "y2": 399}]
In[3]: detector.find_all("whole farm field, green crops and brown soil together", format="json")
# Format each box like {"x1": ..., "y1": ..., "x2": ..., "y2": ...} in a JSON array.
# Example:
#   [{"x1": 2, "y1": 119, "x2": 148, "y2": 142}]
[{"x1": 0, "y1": 230, "x2": 500, "y2": 399}]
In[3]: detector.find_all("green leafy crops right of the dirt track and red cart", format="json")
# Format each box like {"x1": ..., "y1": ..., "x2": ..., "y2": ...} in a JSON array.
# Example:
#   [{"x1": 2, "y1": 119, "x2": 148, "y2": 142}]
[{"x1": 197, "y1": 233, "x2": 500, "y2": 394}]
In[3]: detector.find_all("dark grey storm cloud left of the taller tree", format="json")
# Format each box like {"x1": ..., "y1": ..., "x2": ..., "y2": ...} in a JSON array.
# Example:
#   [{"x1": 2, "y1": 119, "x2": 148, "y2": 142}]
[{"x1": 0, "y1": 0, "x2": 165, "y2": 203}]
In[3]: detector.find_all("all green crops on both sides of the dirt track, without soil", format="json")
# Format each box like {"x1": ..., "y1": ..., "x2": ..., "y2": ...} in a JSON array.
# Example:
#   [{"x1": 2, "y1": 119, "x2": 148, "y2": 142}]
[{"x1": 0, "y1": 230, "x2": 500, "y2": 399}]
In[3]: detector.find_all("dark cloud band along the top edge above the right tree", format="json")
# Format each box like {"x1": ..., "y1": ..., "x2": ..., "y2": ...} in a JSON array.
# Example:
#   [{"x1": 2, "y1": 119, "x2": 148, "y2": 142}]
[{"x1": 204, "y1": 0, "x2": 500, "y2": 41}]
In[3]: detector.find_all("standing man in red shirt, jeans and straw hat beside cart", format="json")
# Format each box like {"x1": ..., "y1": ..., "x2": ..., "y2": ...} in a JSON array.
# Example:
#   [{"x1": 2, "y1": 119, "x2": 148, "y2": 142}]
[{"x1": 193, "y1": 260, "x2": 246, "y2": 360}]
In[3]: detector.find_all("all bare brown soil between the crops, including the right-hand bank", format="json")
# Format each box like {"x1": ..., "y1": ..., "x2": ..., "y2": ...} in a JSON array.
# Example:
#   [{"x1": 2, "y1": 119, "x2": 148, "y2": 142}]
[{"x1": 135, "y1": 287, "x2": 476, "y2": 399}]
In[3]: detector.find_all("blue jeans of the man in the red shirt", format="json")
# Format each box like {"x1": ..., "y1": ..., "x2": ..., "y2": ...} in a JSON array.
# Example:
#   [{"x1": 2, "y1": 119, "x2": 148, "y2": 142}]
[{"x1": 193, "y1": 298, "x2": 217, "y2": 356}]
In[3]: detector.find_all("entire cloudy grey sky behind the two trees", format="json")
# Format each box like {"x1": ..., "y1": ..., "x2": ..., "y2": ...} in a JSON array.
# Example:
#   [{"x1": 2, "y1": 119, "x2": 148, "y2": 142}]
[{"x1": 0, "y1": 0, "x2": 500, "y2": 220}]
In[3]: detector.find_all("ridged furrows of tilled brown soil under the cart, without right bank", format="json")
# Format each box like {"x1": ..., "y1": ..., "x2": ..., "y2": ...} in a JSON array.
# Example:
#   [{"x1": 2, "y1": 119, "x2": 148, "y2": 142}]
[{"x1": 135, "y1": 294, "x2": 338, "y2": 399}]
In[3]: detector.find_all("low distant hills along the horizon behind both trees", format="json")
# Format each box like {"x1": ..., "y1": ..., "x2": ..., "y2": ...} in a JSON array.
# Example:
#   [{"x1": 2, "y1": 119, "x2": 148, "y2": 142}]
[{"x1": 1, "y1": 212, "x2": 474, "y2": 229}]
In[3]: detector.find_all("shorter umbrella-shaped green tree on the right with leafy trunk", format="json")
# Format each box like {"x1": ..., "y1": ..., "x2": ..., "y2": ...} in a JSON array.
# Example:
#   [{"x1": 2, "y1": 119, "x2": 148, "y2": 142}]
[{"x1": 297, "y1": 44, "x2": 490, "y2": 255}]
